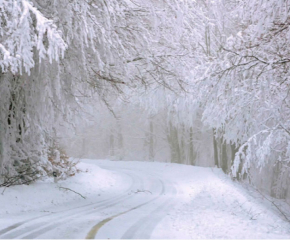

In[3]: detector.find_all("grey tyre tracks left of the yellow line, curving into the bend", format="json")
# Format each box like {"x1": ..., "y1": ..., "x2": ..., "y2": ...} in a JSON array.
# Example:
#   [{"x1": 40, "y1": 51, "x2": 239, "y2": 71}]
[{"x1": 0, "y1": 170, "x2": 143, "y2": 239}]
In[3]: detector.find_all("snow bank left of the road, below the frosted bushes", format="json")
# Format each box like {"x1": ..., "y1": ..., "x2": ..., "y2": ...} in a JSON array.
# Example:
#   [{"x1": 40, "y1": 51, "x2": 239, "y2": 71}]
[{"x1": 0, "y1": 163, "x2": 122, "y2": 215}]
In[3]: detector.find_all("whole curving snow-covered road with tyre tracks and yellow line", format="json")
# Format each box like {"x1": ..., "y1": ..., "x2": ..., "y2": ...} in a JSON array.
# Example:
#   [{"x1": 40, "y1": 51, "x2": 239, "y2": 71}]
[{"x1": 0, "y1": 162, "x2": 177, "y2": 239}]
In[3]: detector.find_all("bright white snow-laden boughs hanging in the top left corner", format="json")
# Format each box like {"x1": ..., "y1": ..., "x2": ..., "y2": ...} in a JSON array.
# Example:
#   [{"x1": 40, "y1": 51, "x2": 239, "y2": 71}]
[{"x1": 0, "y1": 0, "x2": 67, "y2": 74}]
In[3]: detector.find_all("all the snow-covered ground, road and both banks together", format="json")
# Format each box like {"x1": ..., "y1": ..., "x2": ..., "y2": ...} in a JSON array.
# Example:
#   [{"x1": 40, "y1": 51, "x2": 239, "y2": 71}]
[{"x1": 0, "y1": 160, "x2": 290, "y2": 239}]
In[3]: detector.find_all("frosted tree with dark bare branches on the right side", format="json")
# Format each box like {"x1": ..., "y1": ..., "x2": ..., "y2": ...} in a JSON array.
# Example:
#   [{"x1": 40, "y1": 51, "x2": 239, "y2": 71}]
[{"x1": 188, "y1": 1, "x2": 290, "y2": 197}]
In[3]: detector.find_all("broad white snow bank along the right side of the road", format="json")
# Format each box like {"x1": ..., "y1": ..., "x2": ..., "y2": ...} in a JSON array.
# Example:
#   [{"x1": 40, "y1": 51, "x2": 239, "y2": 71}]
[{"x1": 152, "y1": 164, "x2": 290, "y2": 239}]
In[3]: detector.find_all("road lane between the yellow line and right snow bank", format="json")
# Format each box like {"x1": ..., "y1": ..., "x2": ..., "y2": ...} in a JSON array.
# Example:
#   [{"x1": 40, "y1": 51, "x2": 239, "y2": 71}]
[{"x1": 87, "y1": 164, "x2": 177, "y2": 239}]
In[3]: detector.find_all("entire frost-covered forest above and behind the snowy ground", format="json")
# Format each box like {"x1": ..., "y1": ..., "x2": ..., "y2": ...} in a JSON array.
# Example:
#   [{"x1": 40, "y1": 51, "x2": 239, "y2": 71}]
[{"x1": 0, "y1": 0, "x2": 290, "y2": 203}]
